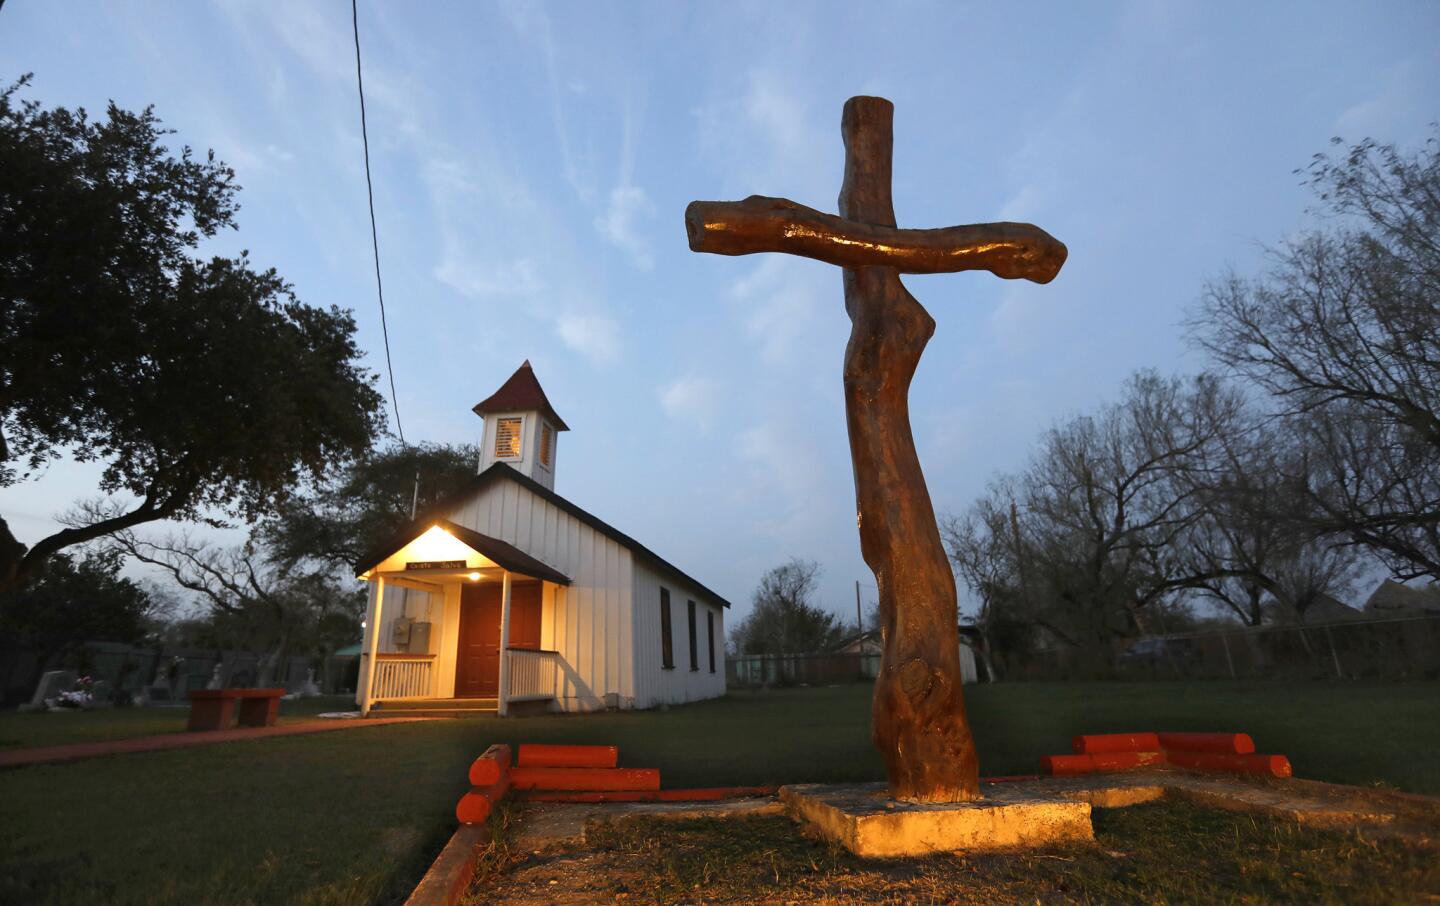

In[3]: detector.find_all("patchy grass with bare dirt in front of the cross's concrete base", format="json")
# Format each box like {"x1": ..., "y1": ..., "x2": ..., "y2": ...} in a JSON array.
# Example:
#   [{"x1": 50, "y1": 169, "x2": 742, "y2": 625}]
[{"x1": 486, "y1": 799, "x2": 1440, "y2": 905}]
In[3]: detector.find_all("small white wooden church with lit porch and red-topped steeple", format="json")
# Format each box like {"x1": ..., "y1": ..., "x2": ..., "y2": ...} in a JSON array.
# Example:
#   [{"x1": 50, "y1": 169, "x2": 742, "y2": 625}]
[{"x1": 356, "y1": 362, "x2": 730, "y2": 714}]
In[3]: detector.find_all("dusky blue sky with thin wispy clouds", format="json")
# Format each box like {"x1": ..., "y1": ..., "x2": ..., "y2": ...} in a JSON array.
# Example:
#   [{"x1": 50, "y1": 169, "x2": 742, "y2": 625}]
[{"x1": 0, "y1": 0, "x2": 1440, "y2": 619}]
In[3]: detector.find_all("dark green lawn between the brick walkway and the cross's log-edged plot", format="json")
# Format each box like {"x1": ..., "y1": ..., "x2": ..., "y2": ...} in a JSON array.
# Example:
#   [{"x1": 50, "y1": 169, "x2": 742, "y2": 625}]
[{"x1": 0, "y1": 683, "x2": 1440, "y2": 903}]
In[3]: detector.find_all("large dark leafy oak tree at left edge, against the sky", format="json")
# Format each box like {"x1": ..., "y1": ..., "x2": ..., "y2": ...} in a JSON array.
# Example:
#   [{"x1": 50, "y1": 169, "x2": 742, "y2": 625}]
[{"x1": 0, "y1": 79, "x2": 383, "y2": 591}]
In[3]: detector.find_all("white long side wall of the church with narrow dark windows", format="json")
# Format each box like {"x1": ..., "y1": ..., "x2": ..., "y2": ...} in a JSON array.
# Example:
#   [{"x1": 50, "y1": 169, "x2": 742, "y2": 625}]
[{"x1": 631, "y1": 563, "x2": 724, "y2": 707}]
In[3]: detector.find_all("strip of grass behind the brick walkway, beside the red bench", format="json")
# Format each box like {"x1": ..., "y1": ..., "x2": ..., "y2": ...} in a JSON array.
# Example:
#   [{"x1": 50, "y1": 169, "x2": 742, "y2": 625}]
[{"x1": 0, "y1": 696, "x2": 356, "y2": 749}]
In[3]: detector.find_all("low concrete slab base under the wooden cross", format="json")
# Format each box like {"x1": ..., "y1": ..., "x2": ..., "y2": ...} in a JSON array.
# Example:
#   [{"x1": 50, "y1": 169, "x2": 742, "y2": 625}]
[{"x1": 780, "y1": 784, "x2": 1094, "y2": 857}]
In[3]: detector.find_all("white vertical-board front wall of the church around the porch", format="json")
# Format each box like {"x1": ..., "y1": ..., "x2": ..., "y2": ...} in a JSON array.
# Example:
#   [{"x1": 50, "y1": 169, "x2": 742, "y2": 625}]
[{"x1": 448, "y1": 481, "x2": 636, "y2": 712}]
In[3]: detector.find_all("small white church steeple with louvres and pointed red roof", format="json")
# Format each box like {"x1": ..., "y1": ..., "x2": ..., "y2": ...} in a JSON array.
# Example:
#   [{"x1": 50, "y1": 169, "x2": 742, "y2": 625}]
[{"x1": 474, "y1": 359, "x2": 569, "y2": 491}]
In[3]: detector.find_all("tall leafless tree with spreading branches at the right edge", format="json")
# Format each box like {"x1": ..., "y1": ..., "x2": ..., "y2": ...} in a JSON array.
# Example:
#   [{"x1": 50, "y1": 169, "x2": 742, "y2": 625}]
[{"x1": 1189, "y1": 127, "x2": 1440, "y2": 580}]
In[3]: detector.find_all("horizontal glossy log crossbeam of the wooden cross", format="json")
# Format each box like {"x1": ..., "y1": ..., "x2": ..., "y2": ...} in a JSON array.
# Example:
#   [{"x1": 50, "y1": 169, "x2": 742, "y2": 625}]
[{"x1": 685, "y1": 194, "x2": 1068, "y2": 284}]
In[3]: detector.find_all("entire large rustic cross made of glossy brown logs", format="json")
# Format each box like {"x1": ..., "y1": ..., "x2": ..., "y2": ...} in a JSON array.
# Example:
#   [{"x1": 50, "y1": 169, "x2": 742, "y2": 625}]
[{"x1": 685, "y1": 97, "x2": 1067, "y2": 802}]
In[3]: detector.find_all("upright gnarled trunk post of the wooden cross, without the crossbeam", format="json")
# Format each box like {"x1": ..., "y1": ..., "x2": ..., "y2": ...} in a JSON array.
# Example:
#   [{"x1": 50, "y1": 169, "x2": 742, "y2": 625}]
[{"x1": 840, "y1": 98, "x2": 979, "y2": 802}]
